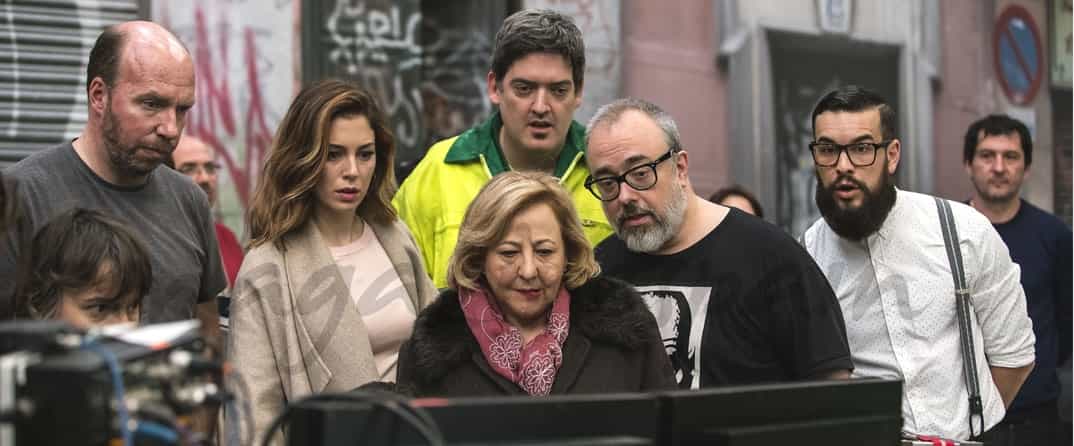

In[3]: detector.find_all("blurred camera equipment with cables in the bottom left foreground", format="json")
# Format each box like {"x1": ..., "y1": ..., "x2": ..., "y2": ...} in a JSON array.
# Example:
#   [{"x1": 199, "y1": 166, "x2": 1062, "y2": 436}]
[{"x1": 0, "y1": 320, "x2": 223, "y2": 446}]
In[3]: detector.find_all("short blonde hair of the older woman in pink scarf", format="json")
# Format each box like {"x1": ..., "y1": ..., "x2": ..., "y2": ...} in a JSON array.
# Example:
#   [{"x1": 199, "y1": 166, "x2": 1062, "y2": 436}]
[{"x1": 448, "y1": 171, "x2": 600, "y2": 289}]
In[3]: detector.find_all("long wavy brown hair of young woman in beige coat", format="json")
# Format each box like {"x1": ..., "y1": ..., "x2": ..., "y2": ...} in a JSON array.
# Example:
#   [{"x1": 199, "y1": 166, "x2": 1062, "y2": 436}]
[{"x1": 247, "y1": 80, "x2": 396, "y2": 249}]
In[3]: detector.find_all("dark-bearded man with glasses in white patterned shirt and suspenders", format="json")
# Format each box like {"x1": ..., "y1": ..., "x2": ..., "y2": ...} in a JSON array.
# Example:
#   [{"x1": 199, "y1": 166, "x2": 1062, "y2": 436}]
[{"x1": 802, "y1": 86, "x2": 1034, "y2": 440}]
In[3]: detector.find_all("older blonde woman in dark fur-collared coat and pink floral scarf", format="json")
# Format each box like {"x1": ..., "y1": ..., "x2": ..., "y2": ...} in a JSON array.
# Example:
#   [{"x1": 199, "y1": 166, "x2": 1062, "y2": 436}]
[{"x1": 398, "y1": 172, "x2": 674, "y2": 397}]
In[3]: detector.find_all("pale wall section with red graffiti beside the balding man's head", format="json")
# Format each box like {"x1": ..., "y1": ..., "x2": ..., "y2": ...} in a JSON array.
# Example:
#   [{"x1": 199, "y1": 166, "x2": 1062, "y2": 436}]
[{"x1": 153, "y1": 0, "x2": 294, "y2": 232}]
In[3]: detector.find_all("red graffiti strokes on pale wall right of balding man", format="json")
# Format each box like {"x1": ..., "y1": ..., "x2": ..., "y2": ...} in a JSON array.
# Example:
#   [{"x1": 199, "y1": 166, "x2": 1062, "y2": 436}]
[{"x1": 187, "y1": 8, "x2": 273, "y2": 207}]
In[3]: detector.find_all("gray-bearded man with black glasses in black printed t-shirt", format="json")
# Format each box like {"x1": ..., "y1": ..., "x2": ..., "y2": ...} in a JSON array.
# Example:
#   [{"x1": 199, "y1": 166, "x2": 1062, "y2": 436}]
[{"x1": 585, "y1": 99, "x2": 853, "y2": 389}]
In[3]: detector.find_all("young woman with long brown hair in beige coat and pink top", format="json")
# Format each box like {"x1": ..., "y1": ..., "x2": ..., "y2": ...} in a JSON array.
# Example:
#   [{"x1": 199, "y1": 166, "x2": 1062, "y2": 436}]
[{"x1": 229, "y1": 81, "x2": 436, "y2": 444}]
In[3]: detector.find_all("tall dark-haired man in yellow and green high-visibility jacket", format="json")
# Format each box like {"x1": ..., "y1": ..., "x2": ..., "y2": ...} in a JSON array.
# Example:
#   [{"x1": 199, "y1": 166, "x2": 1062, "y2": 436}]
[{"x1": 392, "y1": 10, "x2": 612, "y2": 288}]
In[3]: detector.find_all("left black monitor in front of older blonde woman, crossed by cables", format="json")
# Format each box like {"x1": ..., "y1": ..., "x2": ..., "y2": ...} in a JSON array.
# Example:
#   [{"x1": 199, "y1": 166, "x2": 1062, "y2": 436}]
[{"x1": 288, "y1": 393, "x2": 661, "y2": 446}]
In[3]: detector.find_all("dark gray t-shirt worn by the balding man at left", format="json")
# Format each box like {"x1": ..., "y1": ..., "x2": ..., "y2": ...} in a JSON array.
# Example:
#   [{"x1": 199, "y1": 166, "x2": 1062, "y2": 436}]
[{"x1": 0, "y1": 142, "x2": 227, "y2": 323}]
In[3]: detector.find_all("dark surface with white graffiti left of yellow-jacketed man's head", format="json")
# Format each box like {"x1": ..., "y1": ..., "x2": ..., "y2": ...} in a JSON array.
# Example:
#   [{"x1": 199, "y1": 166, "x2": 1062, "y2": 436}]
[{"x1": 315, "y1": 0, "x2": 495, "y2": 165}]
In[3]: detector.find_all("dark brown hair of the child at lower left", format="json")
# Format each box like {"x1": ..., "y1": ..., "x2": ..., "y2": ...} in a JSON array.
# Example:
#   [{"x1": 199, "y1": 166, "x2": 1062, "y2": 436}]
[{"x1": 15, "y1": 207, "x2": 153, "y2": 319}]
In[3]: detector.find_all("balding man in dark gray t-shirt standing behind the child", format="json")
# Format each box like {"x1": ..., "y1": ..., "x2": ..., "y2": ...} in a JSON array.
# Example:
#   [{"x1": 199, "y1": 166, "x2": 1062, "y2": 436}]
[{"x1": 0, "y1": 21, "x2": 227, "y2": 345}]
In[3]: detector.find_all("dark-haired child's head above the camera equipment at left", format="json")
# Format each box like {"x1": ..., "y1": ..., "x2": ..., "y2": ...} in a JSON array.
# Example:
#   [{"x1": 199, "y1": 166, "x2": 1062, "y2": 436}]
[{"x1": 15, "y1": 208, "x2": 153, "y2": 328}]
